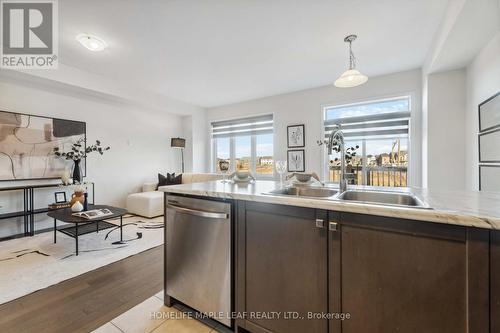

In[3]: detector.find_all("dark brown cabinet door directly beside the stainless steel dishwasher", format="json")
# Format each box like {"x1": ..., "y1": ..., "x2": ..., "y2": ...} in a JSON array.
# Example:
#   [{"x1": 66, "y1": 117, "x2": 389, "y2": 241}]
[{"x1": 237, "y1": 202, "x2": 328, "y2": 333}]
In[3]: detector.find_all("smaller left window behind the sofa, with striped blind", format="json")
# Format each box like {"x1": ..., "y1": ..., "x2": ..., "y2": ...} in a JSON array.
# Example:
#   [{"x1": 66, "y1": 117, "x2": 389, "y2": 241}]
[{"x1": 211, "y1": 115, "x2": 274, "y2": 177}]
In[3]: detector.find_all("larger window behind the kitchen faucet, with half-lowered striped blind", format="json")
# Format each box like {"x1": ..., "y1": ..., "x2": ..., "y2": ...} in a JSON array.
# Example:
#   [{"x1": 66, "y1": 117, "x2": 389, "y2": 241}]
[{"x1": 324, "y1": 96, "x2": 411, "y2": 187}]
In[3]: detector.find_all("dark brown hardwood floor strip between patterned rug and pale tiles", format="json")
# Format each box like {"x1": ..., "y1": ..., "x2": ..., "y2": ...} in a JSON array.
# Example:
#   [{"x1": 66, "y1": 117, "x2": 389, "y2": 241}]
[{"x1": 0, "y1": 245, "x2": 163, "y2": 333}]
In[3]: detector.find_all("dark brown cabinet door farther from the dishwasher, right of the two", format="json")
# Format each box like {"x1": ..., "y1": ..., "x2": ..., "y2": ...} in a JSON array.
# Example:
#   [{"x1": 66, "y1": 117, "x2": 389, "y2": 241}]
[{"x1": 330, "y1": 213, "x2": 489, "y2": 333}]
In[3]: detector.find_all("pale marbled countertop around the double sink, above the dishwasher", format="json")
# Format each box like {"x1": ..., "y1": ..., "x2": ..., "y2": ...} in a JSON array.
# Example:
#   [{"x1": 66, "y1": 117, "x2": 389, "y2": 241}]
[{"x1": 160, "y1": 180, "x2": 500, "y2": 230}]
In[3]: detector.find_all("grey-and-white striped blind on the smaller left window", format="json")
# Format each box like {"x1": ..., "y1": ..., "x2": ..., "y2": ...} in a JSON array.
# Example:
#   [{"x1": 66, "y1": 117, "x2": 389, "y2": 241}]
[{"x1": 211, "y1": 114, "x2": 273, "y2": 138}]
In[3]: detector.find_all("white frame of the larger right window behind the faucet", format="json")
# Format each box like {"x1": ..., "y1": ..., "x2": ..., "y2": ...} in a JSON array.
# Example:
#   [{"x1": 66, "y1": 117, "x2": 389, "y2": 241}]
[{"x1": 321, "y1": 92, "x2": 412, "y2": 187}]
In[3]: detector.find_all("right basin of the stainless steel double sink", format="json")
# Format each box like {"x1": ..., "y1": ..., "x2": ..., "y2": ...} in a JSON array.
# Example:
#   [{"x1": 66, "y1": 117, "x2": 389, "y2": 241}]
[{"x1": 338, "y1": 190, "x2": 429, "y2": 208}]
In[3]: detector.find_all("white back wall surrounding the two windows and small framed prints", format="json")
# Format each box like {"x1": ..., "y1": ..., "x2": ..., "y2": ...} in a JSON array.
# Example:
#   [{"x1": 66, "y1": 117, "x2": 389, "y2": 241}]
[{"x1": 206, "y1": 70, "x2": 422, "y2": 186}]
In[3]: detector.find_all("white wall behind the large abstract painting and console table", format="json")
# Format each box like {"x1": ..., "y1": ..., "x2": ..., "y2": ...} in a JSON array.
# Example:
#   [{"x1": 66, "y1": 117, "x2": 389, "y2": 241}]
[{"x1": 0, "y1": 77, "x2": 197, "y2": 218}]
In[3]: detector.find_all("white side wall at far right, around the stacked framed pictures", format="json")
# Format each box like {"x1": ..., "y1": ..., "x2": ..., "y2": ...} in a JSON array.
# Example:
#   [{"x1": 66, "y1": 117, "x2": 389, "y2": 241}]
[{"x1": 465, "y1": 32, "x2": 500, "y2": 190}]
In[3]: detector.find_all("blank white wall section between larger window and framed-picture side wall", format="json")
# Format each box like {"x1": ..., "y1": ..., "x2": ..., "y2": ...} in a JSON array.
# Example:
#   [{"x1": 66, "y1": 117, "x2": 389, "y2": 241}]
[{"x1": 423, "y1": 69, "x2": 466, "y2": 190}]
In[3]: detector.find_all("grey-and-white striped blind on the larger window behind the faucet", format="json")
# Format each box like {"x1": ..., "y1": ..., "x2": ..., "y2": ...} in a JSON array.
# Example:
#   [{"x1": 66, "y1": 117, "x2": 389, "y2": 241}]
[{"x1": 324, "y1": 97, "x2": 411, "y2": 140}]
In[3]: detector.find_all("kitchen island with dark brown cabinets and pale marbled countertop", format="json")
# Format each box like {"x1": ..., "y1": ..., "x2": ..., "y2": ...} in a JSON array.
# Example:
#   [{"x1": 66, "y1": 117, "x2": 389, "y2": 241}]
[{"x1": 161, "y1": 181, "x2": 500, "y2": 333}]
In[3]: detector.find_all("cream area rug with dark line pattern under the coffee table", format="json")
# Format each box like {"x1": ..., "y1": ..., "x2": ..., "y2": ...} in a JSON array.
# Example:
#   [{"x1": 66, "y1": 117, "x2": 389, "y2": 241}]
[{"x1": 0, "y1": 215, "x2": 163, "y2": 304}]
